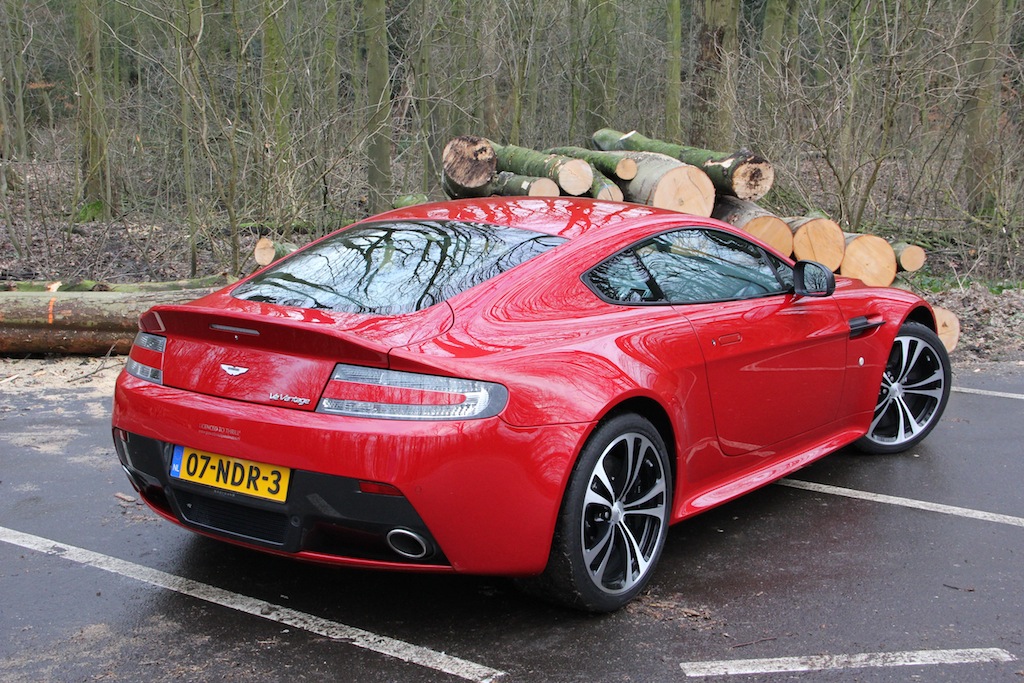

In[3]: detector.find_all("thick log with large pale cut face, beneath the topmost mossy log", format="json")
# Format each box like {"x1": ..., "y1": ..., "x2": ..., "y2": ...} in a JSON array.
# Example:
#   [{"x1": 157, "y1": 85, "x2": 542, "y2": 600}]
[{"x1": 618, "y1": 152, "x2": 715, "y2": 216}]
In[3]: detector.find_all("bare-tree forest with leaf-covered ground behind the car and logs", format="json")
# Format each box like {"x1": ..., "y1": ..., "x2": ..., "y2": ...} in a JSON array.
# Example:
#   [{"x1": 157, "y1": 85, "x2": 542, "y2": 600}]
[{"x1": 0, "y1": 0, "x2": 1024, "y2": 287}]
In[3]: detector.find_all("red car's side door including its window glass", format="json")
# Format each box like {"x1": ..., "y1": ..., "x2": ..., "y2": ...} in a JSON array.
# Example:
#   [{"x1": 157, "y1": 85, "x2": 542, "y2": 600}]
[{"x1": 636, "y1": 227, "x2": 849, "y2": 455}]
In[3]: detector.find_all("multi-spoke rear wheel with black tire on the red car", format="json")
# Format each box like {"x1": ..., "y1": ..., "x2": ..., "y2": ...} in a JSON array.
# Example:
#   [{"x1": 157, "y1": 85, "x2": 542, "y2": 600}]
[{"x1": 520, "y1": 414, "x2": 672, "y2": 612}]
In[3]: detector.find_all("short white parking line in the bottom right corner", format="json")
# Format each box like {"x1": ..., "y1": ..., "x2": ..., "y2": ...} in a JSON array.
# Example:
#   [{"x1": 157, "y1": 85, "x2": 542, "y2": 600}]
[{"x1": 679, "y1": 647, "x2": 1017, "y2": 678}]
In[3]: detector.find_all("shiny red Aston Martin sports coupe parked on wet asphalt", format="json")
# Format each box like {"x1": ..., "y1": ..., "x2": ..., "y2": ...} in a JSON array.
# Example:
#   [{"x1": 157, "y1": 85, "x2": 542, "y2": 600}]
[{"x1": 114, "y1": 198, "x2": 950, "y2": 611}]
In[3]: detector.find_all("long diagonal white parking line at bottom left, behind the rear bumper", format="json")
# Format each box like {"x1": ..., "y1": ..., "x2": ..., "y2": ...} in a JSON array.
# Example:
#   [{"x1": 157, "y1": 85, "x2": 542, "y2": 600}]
[{"x1": 0, "y1": 526, "x2": 505, "y2": 683}]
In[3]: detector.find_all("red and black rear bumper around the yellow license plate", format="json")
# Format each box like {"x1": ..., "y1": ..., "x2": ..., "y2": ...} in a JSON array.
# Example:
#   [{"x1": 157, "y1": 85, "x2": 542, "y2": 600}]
[{"x1": 113, "y1": 374, "x2": 589, "y2": 575}]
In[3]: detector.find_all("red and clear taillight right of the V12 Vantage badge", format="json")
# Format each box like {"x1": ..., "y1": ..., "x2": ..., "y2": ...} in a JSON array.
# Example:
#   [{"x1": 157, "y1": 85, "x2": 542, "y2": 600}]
[{"x1": 316, "y1": 365, "x2": 509, "y2": 420}]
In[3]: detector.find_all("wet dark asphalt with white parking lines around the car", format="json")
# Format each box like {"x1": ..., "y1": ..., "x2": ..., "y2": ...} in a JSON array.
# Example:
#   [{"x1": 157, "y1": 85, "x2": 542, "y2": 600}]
[{"x1": 0, "y1": 366, "x2": 1024, "y2": 682}]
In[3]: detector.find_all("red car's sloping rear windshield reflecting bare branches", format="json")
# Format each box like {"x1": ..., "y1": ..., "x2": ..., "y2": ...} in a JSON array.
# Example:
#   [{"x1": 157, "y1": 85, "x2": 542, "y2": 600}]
[{"x1": 232, "y1": 221, "x2": 565, "y2": 315}]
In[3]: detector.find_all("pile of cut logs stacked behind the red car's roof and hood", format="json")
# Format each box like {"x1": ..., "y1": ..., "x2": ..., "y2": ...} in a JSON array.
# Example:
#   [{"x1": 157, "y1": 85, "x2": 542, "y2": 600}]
[{"x1": 441, "y1": 128, "x2": 959, "y2": 350}]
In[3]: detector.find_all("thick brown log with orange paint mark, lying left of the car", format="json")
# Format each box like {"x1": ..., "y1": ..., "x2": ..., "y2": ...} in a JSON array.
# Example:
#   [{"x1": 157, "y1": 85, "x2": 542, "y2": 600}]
[{"x1": 0, "y1": 289, "x2": 213, "y2": 355}]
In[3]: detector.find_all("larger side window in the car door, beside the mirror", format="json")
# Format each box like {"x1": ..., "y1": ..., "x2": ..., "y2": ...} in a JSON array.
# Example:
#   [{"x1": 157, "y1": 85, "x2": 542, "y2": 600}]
[{"x1": 636, "y1": 228, "x2": 792, "y2": 303}]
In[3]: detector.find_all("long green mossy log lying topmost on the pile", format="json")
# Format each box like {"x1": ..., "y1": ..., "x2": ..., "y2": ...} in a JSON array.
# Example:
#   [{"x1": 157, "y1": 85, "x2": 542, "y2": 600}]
[{"x1": 592, "y1": 128, "x2": 775, "y2": 201}]
